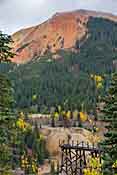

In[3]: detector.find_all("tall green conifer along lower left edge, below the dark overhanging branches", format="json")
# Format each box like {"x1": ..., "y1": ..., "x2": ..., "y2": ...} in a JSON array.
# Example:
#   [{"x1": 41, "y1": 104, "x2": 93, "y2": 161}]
[{"x1": 0, "y1": 75, "x2": 15, "y2": 171}]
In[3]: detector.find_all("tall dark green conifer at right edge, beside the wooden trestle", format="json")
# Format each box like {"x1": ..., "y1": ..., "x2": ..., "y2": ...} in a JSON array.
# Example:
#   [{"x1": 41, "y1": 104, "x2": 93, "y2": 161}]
[{"x1": 101, "y1": 73, "x2": 117, "y2": 175}]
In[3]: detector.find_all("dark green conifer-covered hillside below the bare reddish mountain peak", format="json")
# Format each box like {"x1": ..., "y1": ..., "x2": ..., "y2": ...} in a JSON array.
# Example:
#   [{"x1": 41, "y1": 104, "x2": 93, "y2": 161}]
[{"x1": 0, "y1": 18, "x2": 117, "y2": 112}]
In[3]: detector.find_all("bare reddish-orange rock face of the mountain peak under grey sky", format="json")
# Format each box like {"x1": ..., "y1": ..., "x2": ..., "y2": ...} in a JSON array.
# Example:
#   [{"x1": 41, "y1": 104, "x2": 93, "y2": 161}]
[{"x1": 12, "y1": 10, "x2": 117, "y2": 64}]
